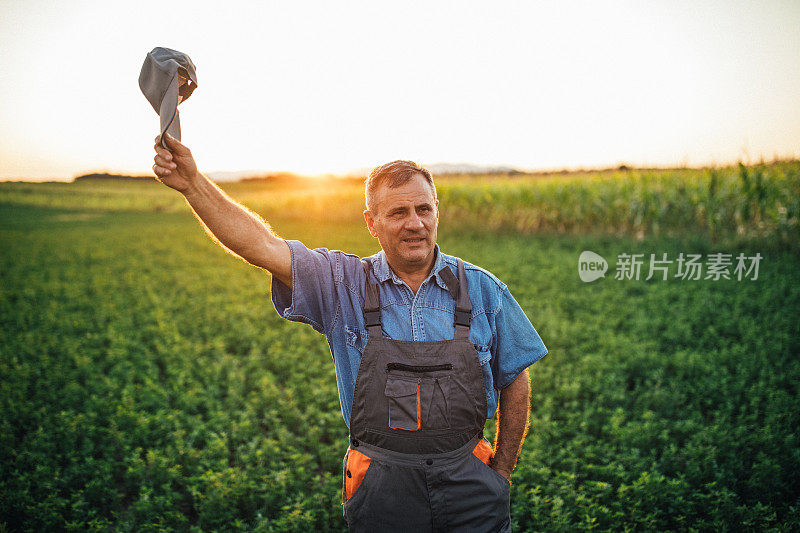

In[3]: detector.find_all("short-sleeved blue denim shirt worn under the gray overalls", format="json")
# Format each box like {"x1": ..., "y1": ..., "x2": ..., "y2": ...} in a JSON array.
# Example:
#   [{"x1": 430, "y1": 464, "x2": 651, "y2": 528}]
[{"x1": 272, "y1": 240, "x2": 547, "y2": 428}]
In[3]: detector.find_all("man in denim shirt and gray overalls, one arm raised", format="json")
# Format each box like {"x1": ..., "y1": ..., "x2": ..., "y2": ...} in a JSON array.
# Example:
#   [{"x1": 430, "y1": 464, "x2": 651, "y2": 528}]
[{"x1": 153, "y1": 137, "x2": 547, "y2": 532}]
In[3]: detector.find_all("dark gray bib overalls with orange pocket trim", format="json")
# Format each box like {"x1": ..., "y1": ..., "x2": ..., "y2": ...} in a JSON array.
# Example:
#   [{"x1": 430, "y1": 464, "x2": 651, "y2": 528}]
[{"x1": 342, "y1": 259, "x2": 511, "y2": 533}]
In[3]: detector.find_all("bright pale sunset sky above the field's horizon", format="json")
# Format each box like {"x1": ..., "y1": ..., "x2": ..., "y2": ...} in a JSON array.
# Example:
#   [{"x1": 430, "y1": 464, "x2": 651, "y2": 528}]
[{"x1": 0, "y1": 0, "x2": 800, "y2": 180}]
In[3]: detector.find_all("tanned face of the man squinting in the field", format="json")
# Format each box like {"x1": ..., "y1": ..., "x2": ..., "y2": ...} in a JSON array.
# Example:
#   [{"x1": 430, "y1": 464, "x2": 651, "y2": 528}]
[{"x1": 364, "y1": 174, "x2": 439, "y2": 270}]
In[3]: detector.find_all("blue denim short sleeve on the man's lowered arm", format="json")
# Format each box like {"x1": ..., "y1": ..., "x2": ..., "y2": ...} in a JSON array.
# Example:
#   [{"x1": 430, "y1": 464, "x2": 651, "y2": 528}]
[{"x1": 492, "y1": 288, "x2": 547, "y2": 390}]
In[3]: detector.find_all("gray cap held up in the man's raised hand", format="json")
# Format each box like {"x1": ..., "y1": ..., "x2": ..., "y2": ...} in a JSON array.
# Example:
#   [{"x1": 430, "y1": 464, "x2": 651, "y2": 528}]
[{"x1": 139, "y1": 46, "x2": 197, "y2": 148}]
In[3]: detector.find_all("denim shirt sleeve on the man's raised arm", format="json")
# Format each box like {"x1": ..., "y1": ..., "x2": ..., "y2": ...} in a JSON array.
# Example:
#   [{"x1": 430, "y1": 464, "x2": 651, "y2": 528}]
[{"x1": 271, "y1": 240, "x2": 338, "y2": 334}]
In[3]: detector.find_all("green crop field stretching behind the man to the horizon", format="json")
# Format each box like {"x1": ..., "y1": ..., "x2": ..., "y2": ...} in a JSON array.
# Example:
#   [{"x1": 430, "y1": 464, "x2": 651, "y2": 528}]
[{"x1": 0, "y1": 162, "x2": 800, "y2": 531}]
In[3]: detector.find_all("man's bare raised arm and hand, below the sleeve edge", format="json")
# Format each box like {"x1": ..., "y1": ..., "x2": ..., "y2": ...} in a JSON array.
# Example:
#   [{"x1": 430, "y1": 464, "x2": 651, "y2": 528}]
[{"x1": 153, "y1": 135, "x2": 292, "y2": 288}]
